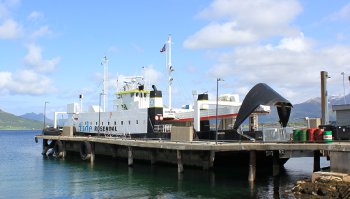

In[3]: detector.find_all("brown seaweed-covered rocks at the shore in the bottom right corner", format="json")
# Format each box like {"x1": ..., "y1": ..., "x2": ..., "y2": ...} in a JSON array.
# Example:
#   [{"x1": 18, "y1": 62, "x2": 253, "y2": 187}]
[{"x1": 292, "y1": 172, "x2": 350, "y2": 199}]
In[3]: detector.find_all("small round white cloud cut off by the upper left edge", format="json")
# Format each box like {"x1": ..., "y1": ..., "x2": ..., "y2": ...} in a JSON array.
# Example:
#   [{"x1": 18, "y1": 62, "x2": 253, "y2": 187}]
[{"x1": 0, "y1": 19, "x2": 22, "y2": 39}]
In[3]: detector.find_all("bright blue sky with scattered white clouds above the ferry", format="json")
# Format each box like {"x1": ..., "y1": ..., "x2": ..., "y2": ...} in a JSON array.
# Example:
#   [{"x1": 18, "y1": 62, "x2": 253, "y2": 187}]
[{"x1": 0, "y1": 0, "x2": 350, "y2": 116}]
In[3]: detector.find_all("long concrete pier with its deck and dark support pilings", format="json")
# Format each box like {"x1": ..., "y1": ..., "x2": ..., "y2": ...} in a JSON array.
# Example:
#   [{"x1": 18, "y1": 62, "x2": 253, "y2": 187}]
[{"x1": 36, "y1": 135, "x2": 350, "y2": 181}]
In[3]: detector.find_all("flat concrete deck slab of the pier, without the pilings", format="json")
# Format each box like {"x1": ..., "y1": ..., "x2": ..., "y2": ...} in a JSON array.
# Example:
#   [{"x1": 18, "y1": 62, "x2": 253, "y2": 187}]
[{"x1": 36, "y1": 135, "x2": 350, "y2": 152}]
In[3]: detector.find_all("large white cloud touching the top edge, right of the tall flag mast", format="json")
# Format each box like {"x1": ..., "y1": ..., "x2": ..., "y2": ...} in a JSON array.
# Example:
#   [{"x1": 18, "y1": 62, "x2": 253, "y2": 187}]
[{"x1": 184, "y1": 0, "x2": 301, "y2": 48}]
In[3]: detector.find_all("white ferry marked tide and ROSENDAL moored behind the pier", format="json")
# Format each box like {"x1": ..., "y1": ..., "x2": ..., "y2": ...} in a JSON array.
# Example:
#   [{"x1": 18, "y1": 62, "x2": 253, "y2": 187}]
[{"x1": 44, "y1": 35, "x2": 276, "y2": 139}]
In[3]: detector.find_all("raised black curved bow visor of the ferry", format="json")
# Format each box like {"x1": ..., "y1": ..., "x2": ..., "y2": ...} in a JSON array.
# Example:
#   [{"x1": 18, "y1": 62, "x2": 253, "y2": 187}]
[{"x1": 233, "y1": 83, "x2": 293, "y2": 130}]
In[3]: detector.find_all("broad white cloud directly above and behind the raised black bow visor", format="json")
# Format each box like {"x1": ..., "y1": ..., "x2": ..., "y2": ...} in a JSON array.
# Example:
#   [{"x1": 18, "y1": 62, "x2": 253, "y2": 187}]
[{"x1": 209, "y1": 37, "x2": 350, "y2": 102}]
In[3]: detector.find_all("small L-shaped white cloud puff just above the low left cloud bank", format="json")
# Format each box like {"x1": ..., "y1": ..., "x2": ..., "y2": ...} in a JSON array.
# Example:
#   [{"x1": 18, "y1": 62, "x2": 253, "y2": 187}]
[{"x1": 24, "y1": 44, "x2": 60, "y2": 72}]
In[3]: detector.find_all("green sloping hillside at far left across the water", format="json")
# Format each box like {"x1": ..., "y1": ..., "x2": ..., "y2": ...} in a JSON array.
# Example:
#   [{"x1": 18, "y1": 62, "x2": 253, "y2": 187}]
[{"x1": 0, "y1": 109, "x2": 43, "y2": 130}]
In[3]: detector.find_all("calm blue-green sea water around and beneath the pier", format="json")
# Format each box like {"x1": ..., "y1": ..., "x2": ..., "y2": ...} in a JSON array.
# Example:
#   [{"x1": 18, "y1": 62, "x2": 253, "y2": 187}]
[{"x1": 0, "y1": 131, "x2": 329, "y2": 198}]
